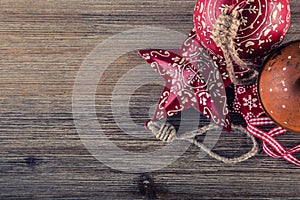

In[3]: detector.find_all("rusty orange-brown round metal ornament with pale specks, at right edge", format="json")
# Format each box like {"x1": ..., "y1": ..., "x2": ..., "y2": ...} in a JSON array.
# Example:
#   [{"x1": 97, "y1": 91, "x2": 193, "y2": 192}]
[{"x1": 258, "y1": 40, "x2": 300, "y2": 133}]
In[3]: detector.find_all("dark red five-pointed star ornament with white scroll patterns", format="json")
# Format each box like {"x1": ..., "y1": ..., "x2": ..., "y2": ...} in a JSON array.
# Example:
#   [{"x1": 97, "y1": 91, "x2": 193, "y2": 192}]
[{"x1": 139, "y1": 29, "x2": 230, "y2": 131}]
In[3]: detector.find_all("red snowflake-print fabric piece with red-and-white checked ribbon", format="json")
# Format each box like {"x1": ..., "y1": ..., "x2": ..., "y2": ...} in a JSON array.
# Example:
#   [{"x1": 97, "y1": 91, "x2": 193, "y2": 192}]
[{"x1": 230, "y1": 84, "x2": 300, "y2": 166}]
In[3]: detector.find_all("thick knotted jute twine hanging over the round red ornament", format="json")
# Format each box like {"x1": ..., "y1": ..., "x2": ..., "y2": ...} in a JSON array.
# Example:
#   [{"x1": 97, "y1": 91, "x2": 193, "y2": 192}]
[{"x1": 212, "y1": 1, "x2": 258, "y2": 85}]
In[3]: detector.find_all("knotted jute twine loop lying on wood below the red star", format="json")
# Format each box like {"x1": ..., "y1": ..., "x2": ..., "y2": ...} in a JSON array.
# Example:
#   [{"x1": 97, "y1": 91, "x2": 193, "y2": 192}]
[{"x1": 147, "y1": 121, "x2": 258, "y2": 163}]
